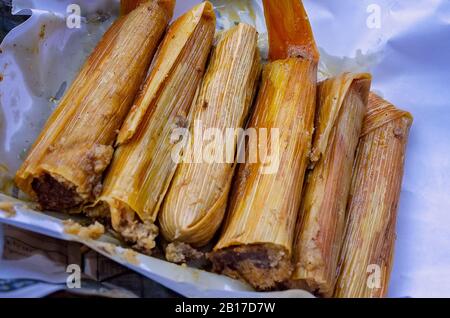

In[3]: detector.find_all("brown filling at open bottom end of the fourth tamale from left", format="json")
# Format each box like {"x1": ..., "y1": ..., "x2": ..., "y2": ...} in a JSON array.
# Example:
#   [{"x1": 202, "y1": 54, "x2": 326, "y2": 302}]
[{"x1": 210, "y1": 244, "x2": 292, "y2": 290}]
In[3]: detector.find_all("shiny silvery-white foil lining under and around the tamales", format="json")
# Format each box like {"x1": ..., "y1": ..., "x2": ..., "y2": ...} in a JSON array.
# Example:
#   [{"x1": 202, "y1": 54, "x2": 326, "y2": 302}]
[{"x1": 0, "y1": 0, "x2": 450, "y2": 297}]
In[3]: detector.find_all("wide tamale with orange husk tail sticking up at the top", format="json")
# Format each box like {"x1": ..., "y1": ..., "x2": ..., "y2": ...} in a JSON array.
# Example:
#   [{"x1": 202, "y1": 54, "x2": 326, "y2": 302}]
[{"x1": 210, "y1": 0, "x2": 318, "y2": 290}]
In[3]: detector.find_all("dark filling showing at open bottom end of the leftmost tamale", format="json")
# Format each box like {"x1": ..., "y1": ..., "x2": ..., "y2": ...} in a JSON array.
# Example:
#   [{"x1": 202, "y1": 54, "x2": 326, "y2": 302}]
[{"x1": 31, "y1": 174, "x2": 83, "y2": 210}]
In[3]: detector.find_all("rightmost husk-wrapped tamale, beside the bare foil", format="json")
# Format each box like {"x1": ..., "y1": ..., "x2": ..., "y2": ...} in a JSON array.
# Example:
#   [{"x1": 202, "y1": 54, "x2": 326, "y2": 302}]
[{"x1": 334, "y1": 93, "x2": 412, "y2": 298}]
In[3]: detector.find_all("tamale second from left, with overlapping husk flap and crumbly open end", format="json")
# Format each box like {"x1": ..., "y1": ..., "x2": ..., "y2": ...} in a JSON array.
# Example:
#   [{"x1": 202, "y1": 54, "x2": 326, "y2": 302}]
[{"x1": 91, "y1": 2, "x2": 215, "y2": 253}]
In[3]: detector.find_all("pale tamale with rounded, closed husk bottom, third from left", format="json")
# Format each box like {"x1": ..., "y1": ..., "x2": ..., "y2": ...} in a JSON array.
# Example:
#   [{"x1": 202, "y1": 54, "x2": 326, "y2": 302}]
[{"x1": 159, "y1": 23, "x2": 260, "y2": 246}]
